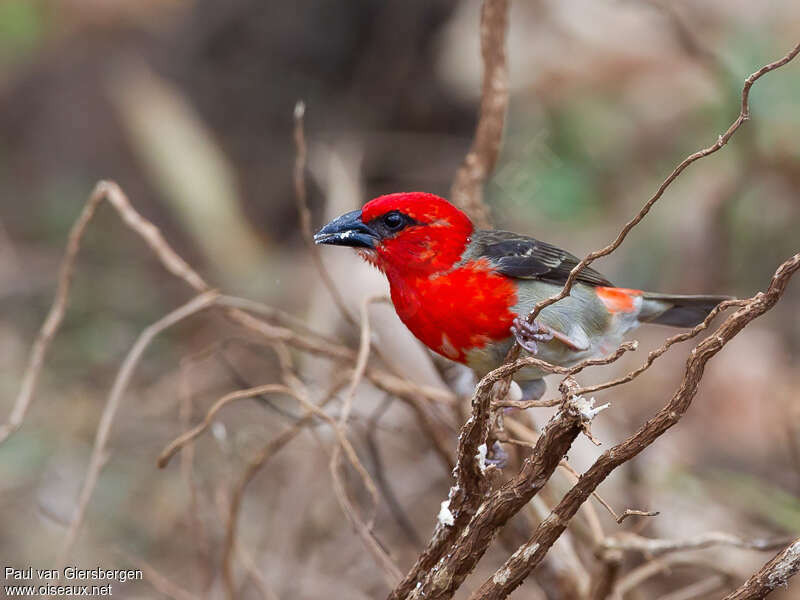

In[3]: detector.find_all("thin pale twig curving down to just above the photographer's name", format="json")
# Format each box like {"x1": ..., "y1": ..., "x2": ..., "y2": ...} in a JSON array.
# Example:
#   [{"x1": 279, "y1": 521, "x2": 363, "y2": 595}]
[{"x1": 56, "y1": 291, "x2": 217, "y2": 565}]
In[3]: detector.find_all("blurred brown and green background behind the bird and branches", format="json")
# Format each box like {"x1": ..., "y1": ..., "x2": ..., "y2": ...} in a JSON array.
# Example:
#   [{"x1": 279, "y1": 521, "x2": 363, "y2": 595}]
[{"x1": 0, "y1": 0, "x2": 800, "y2": 598}]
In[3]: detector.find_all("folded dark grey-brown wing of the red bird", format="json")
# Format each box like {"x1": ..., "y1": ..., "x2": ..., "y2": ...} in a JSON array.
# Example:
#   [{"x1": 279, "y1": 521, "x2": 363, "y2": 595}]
[{"x1": 465, "y1": 231, "x2": 613, "y2": 286}]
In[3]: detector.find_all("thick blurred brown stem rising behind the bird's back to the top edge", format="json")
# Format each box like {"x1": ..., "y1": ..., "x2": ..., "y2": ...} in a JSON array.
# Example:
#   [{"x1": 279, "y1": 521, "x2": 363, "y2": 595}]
[{"x1": 450, "y1": 0, "x2": 509, "y2": 227}]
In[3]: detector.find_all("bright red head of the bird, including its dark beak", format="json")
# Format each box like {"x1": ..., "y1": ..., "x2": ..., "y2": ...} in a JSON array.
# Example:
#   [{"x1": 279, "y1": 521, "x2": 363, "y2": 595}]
[{"x1": 314, "y1": 192, "x2": 473, "y2": 275}]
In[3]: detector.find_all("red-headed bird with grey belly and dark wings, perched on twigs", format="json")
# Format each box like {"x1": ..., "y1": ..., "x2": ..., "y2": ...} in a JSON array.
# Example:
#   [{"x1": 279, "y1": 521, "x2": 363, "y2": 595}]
[{"x1": 314, "y1": 192, "x2": 727, "y2": 398}]
